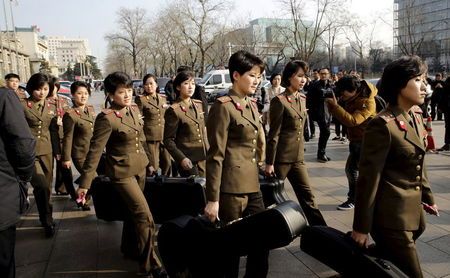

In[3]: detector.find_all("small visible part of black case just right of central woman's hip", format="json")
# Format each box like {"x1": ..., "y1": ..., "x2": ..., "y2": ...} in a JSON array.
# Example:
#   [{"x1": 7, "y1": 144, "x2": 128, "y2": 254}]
[{"x1": 259, "y1": 173, "x2": 289, "y2": 208}]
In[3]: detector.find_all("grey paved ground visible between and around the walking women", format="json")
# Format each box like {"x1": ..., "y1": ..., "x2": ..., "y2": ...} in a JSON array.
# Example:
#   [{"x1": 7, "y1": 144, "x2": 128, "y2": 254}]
[{"x1": 16, "y1": 121, "x2": 450, "y2": 278}]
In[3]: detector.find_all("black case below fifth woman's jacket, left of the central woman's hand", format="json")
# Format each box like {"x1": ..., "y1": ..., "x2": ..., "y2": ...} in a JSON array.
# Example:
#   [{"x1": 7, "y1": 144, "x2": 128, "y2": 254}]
[{"x1": 144, "y1": 176, "x2": 206, "y2": 224}]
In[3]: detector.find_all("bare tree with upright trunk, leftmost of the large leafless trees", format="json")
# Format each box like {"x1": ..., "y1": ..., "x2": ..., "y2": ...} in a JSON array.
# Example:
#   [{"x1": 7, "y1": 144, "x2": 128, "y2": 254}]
[{"x1": 105, "y1": 8, "x2": 148, "y2": 77}]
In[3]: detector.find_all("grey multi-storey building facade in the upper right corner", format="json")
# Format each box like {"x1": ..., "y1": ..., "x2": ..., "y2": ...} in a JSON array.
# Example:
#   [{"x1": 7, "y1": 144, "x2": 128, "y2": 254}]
[{"x1": 394, "y1": 0, "x2": 450, "y2": 71}]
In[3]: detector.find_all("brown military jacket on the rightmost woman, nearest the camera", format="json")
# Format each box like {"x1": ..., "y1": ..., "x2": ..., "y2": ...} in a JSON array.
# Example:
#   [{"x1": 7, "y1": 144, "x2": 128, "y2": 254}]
[{"x1": 353, "y1": 106, "x2": 434, "y2": 233}]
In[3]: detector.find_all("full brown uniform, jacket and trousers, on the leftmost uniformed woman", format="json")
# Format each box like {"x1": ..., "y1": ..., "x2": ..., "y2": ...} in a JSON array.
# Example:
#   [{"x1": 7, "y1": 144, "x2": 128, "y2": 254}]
[{"x1": 21, "y1": 97, "x2": 60, "y2": 226}]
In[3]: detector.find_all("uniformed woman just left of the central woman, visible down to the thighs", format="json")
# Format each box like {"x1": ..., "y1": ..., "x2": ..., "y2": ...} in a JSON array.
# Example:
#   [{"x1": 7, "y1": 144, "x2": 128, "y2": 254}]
[{"x1": 164, "y1": 71, "x2": 207, "y2": 177}]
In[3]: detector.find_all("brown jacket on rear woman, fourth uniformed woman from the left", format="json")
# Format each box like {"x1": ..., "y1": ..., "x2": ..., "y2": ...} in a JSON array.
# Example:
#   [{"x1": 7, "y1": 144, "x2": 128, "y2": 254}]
[{"x1": 135, "y1": 94, "x2": 169, "y2": 141}]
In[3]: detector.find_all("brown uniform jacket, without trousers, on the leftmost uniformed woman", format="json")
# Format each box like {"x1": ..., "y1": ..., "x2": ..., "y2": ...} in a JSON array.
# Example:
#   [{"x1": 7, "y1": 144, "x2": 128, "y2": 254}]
[{"x1": 20, "y1": 97, "x2": 61, "y2": 156}]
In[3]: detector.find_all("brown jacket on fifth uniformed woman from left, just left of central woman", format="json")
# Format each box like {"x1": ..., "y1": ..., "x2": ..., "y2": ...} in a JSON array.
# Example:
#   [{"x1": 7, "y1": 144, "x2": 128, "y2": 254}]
[{"x1": 164, "y1": 99, "x2": 206, "y2": 163}]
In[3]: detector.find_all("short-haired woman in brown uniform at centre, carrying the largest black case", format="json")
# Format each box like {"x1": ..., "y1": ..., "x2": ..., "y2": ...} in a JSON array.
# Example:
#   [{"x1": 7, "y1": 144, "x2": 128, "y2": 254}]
[{"x1": 205, "y1": 51, "x2": 270, "y2": 277}]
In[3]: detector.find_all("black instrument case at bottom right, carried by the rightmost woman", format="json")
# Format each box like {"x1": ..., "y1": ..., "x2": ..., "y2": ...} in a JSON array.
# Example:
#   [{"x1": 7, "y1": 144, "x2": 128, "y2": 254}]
[{"x1": 300, "y1": 226, "x2": 408, "y2": 278}]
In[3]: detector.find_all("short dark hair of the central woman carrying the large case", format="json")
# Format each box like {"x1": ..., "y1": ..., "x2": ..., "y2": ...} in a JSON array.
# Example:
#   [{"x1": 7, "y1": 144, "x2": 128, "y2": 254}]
[{"x1": 228, "y1": 50, "x2": 265, "y2": 83}]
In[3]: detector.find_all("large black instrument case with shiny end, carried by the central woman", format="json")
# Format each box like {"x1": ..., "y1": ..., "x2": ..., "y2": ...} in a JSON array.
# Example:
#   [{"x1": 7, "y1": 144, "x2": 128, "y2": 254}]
[{"x1": 158, "y1": 201, "x2": 306, "y2": 277}]
